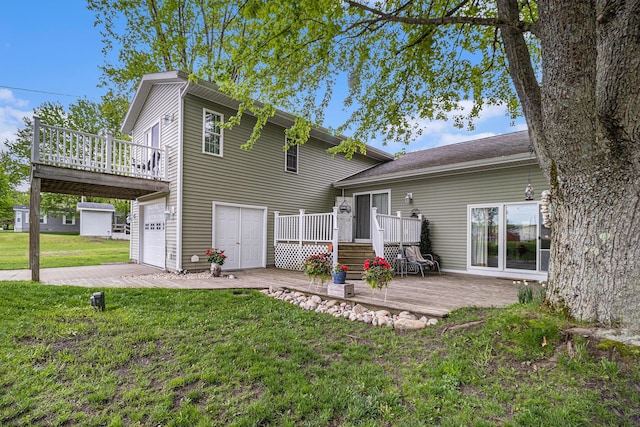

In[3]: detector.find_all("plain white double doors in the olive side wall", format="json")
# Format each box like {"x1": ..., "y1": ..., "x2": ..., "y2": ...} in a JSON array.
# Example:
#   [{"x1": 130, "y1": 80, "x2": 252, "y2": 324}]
[{"x1": 213, "y1": 203, "x2": 266, "y2": 269}]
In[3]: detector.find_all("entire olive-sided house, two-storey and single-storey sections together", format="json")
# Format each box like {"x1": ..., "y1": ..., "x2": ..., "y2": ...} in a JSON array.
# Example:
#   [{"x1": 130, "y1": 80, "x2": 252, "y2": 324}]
[{"x1": 122, "y1": 72, "x2": 550, "y2": 279}]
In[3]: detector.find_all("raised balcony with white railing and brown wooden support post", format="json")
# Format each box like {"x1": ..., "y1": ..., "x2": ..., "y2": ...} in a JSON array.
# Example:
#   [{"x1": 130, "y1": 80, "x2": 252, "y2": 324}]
[{"x1": 29, "y1": 117, "x2": 169, "y2": 282}]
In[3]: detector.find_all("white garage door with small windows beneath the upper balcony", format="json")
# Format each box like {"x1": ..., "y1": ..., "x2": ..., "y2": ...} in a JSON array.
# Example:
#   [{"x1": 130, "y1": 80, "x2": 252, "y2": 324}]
[{"x1": 142, "y1": 202, "x2": 165, "y2": 268}]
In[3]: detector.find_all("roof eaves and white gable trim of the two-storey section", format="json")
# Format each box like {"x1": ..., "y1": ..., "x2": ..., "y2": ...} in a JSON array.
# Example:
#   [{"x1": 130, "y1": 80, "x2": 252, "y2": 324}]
[{"x1": 120, "y1": 71, "x2": 393, "y2": 161}]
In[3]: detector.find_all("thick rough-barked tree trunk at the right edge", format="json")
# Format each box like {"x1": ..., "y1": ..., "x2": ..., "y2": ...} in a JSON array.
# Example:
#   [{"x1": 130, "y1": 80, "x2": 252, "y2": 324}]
[{"x1": 532, "y1": 0, "x2": 640, "y2": 329}]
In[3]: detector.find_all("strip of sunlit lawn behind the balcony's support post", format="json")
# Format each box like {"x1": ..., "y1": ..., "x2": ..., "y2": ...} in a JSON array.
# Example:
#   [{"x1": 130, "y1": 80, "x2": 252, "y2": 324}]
[{"x1": 0, "y1": 231, "x2": 129, "y2": 270}]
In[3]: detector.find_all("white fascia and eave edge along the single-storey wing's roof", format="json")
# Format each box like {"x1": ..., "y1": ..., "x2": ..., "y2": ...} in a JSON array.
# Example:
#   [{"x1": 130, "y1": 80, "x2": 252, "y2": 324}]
[{"x1": 333, "y1": 153, "x2": 537, "y2": 188}]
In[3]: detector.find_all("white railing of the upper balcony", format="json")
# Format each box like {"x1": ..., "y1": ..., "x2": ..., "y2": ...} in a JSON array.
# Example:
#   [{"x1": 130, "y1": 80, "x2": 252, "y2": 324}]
[{"x1": 31, "y1": 117, "x2": 167, "y2": 180}]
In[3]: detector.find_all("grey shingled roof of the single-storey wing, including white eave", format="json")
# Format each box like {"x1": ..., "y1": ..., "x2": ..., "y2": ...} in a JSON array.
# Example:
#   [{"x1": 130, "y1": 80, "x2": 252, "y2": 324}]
[{"x1": 334, "y1": 131, "x2": 537, "y2": 188}]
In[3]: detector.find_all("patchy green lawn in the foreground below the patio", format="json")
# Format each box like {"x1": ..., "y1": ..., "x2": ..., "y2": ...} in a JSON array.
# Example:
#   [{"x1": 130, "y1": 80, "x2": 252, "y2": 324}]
[{"x1": 0, "y1": 282, "x2": 640, "y2": 426}]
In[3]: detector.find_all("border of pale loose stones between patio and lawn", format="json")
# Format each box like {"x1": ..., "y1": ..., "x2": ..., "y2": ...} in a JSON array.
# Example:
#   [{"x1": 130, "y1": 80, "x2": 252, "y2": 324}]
[{"x1": 260, "y1": 286, "x2": 438, "y2": 330}]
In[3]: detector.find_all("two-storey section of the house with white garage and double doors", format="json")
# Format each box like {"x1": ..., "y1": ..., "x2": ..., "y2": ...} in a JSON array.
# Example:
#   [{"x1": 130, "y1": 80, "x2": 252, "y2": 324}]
[{"x1": 122, "y1": 72, "x2": 393, "y2": 270}]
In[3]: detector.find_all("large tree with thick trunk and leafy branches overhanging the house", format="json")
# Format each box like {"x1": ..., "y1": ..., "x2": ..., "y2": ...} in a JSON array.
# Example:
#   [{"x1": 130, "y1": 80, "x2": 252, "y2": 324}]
[{"x1": 90, "y1": 0, "x2": 640, "y2": 327}]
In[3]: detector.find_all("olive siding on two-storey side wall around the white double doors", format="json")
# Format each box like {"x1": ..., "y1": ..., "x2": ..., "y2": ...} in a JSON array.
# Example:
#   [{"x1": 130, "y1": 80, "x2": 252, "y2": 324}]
[{"x1": 182, "y1": 95, "x2": 378, "y2": 269}]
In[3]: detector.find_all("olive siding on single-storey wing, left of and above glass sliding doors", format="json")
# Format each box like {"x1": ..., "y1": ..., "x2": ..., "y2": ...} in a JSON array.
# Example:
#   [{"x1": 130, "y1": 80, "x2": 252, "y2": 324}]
[{"x1": 345, "y1": 165, "x2": 549, "y2": 271}]
